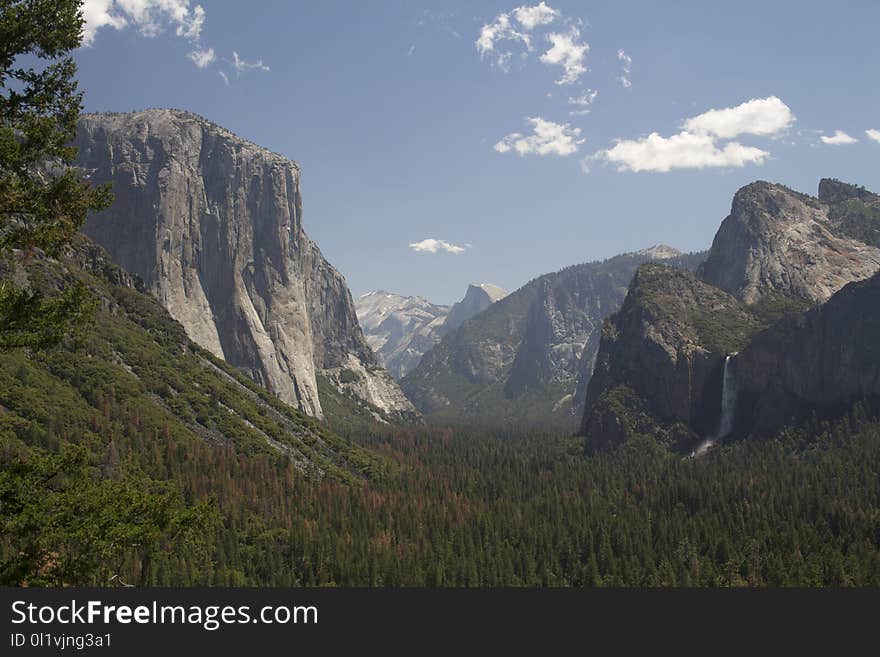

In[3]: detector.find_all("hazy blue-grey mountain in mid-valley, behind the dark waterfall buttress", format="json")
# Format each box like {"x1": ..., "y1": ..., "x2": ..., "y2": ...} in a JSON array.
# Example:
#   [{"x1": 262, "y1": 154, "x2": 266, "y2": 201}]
[{"x1": 401, "y1": 245, "x2": 704, "y2": 426}]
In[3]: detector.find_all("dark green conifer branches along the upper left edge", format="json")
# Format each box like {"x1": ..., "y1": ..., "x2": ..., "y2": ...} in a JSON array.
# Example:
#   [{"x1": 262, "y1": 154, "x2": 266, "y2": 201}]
[{"x1": 0, "y1": 0, "x2": 110, "y2": 349}]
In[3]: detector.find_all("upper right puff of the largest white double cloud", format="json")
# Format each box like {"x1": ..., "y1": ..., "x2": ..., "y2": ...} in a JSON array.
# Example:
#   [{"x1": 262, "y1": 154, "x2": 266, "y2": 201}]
[{"x1": 682, "y1": 96, "x2": 794, "y2": 139}]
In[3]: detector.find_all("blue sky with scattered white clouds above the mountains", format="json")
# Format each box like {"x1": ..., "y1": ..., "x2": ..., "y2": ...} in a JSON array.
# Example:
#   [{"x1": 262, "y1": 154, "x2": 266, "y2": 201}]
[{"x1": 75, "y1": 0, "x2": 880, "y2": 303}]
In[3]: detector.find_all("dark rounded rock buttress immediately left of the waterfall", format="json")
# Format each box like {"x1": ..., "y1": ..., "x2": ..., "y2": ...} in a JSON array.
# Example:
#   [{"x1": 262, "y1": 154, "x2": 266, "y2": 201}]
[{"x1": 581, "y1": 263, "x2": 761, "y2": 448}]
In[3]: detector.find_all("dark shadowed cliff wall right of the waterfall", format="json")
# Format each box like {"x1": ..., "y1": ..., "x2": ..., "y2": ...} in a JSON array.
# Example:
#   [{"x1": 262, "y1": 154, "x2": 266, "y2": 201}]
[{"x1": 734, "y1": 274, "x2": 880, "y2": 435}]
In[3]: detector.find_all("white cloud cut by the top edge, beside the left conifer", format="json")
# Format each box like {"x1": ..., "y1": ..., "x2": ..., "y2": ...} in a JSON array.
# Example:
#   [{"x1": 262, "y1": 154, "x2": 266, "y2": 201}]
[{"x1": 82, "y1": 0, "x2": 205, "y2": 46}]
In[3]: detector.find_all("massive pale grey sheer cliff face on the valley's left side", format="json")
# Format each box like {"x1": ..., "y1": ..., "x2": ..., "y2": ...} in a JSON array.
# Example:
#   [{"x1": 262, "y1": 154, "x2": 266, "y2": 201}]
[{"x1": 75, "y1": 110, "x2": 413, "y2": 417}]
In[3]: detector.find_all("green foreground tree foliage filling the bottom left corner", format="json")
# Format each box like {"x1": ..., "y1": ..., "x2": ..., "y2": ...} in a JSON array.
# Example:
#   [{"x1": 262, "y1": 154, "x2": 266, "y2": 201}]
[{"x1": 0, "y1": 434, "x2": 219, "y2": 586}]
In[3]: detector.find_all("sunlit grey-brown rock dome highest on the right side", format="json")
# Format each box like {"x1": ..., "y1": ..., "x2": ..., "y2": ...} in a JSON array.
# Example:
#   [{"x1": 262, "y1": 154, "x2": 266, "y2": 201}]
[{"x1": 699, "y1": 181, "x2": 880, "y2": 303}]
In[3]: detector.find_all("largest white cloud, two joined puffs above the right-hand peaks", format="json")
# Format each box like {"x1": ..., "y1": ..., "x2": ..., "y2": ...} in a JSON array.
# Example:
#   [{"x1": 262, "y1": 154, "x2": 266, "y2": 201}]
[{"x1": 581, "y1": 96, "x2": 795, "y2": 172}]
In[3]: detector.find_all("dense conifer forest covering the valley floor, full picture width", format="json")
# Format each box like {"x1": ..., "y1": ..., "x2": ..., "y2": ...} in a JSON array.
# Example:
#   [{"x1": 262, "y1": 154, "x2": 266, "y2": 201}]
[{"x1": 0, "y1": 394, "x2": 880, "y2": 587}]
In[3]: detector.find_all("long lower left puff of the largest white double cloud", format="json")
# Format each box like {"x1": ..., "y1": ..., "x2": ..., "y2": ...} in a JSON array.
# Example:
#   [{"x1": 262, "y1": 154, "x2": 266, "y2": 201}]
[{"x1": 585, "y1": 132, "x2": 770, "y2": 172}]
